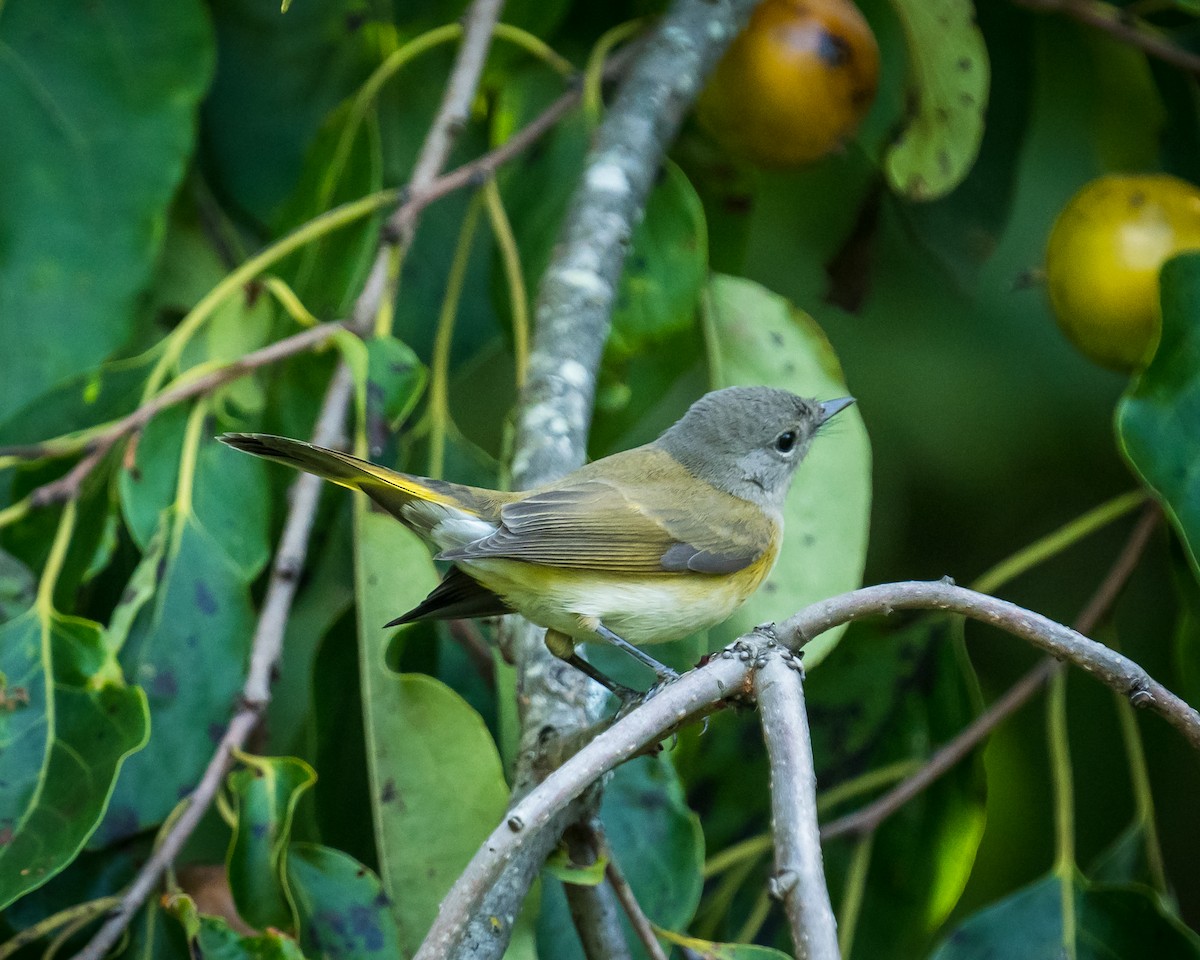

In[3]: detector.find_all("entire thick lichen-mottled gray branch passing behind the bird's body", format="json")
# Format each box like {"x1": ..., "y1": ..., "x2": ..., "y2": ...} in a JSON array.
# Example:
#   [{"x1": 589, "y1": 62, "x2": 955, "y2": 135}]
[{"x1": 455, "y1": 0, "x2": 755, "y2": 958}]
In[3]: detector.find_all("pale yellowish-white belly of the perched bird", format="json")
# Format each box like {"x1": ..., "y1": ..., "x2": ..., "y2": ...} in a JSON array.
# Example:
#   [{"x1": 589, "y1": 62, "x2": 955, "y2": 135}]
[{"x1": 461, "y1": 552, "x2": 775, "y2": 644}]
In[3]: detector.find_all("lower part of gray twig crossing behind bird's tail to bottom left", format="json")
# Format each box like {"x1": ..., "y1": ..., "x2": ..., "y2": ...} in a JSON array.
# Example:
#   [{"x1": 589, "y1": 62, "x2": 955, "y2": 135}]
[{"x1": 74, "y1": 365, "x2": 353, "y2": 960}]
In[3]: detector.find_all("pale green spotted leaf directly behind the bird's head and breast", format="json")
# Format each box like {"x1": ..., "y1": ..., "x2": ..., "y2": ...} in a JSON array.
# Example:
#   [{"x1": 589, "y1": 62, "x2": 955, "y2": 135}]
[{"x1": 708, "y1": 275, "x2": 871, "y2": 667}]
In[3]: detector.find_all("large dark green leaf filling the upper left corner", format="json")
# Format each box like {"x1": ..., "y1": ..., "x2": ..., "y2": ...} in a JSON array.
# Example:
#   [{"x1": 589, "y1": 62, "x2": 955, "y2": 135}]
[{"x1": 0, "y1": 0, "x2": 214, "y2": 410}]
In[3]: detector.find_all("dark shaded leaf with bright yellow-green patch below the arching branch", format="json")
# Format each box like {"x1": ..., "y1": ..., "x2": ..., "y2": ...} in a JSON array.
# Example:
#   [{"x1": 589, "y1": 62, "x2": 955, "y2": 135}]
[{"x1": 806, "y1": 619, "x2": 986, "y2": 956}]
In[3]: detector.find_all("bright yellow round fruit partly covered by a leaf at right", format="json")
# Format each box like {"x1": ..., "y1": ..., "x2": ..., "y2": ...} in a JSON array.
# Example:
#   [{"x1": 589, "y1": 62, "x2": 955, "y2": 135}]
[{"x1": 1045, "y1": 174, "x2": 1200, "y2": 370}]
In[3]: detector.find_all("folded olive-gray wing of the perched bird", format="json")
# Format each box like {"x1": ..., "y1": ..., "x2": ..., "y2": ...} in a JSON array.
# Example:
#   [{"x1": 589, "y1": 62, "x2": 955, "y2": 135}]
[{"x1": 442, "y1": 478, "x2": 776, "y2": 574}]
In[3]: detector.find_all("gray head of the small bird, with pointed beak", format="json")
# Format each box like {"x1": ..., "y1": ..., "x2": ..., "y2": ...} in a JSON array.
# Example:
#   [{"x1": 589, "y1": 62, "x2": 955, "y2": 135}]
[{"x1": 654, "y1": 386, "x2": 854, "y2": 510}]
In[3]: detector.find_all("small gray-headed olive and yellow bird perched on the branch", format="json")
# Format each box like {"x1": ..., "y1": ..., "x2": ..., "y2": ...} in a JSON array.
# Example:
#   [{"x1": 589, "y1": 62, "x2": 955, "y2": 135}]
[{"x1": 221, "y1": 386, "x2": 854, "y2": 686}]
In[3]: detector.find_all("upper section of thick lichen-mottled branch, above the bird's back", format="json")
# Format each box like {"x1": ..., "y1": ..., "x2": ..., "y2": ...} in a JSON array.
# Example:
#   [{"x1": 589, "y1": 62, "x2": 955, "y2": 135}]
[{"x1": 512, "y1": 0, "x2": 755, "y2": 487}]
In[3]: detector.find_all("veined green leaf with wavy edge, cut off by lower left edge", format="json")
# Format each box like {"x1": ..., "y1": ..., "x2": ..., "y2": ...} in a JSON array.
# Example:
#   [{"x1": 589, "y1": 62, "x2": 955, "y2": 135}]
[{"x1": 0, "y1": 606, "x2": 149, "y2": 907}]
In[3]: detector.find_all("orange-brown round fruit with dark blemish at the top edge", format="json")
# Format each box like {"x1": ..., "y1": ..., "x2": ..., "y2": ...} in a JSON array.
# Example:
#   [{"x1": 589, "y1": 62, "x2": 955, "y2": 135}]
[{"x1": 697, "y1": 0, "x2": 880, "y2": 167}]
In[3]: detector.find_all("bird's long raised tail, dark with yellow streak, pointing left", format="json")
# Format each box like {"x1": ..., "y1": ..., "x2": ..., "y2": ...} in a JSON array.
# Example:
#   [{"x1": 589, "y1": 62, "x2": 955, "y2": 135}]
[{"x1": 220, "y1": 433, "x2": 511, "y2": 532}]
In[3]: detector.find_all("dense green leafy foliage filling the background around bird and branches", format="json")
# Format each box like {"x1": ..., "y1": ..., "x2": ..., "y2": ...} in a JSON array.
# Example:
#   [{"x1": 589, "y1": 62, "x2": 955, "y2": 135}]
[{"x1": 0, "y1": 0, "x2": 1200, "y2": 958}]
